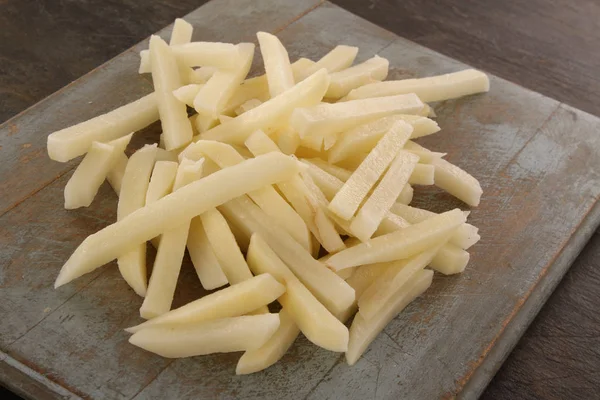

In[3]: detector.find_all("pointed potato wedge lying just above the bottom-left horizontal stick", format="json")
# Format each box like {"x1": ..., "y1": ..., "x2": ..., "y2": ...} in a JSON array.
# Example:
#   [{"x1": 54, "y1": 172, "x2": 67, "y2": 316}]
[{"x1": 126, "y1": 274, "x2": 285, "y2": 333}]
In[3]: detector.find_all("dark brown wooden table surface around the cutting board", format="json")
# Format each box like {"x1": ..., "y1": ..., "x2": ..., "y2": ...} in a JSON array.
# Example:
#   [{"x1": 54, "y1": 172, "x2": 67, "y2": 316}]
[{"x1": 0, "y1": 0, "x2": 600, "y2": 399}]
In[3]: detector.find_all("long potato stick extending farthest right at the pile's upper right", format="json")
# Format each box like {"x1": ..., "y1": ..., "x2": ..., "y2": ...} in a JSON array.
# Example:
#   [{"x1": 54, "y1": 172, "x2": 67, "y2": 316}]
[{"x1": 344, "y1": 69, "x2": 490, "y2": 102}]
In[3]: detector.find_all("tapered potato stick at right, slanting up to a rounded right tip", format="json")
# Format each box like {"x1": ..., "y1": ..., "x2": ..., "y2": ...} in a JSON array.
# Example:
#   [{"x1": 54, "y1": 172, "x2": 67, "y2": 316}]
[{"x1": 327, "y1": 209, "x2": 466, "y2": 271}]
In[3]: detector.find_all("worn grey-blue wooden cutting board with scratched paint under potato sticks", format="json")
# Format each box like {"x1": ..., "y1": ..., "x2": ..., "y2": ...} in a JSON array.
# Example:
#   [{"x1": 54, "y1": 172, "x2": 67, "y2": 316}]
[{"x1": 0, "y1": 0, "x2": 600, "y2": 399}]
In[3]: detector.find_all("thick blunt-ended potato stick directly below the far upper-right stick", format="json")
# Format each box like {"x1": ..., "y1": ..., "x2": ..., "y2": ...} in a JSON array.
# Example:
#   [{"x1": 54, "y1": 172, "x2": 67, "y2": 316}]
[{"x1": 290, "y1": 93, "x2": 423, "y2": 138}]
